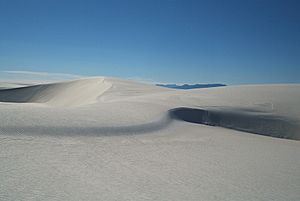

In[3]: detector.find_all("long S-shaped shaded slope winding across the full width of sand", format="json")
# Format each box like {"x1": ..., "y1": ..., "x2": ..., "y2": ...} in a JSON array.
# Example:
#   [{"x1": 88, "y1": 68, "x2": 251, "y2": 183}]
[{"x1": 0, "y1": 107, "x2": 300, "y2": 140}]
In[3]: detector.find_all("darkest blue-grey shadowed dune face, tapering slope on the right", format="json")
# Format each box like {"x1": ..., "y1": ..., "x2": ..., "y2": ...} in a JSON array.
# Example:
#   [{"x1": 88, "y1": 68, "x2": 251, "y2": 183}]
[{"x1": 169, "y1": 107, "x2": 300, "y2": 140}]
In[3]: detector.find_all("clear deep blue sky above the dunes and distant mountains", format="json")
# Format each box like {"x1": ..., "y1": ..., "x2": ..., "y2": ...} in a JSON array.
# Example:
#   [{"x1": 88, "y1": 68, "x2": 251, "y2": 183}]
[{"x1": 0, "y1": 0, "x2": 300, "y2": 84}]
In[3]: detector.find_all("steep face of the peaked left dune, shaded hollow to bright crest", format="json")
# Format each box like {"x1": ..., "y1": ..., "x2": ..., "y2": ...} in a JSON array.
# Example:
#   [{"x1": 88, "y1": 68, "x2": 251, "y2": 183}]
[{"x1": 0, "y1": 77, "x2": 112, "y2": 107}]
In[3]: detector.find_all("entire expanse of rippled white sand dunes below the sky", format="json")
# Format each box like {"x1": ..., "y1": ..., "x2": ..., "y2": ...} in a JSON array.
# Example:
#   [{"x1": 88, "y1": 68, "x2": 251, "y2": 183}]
[{"x1": 0, "y1": 77, "x2": 300, "y2": 201}]
